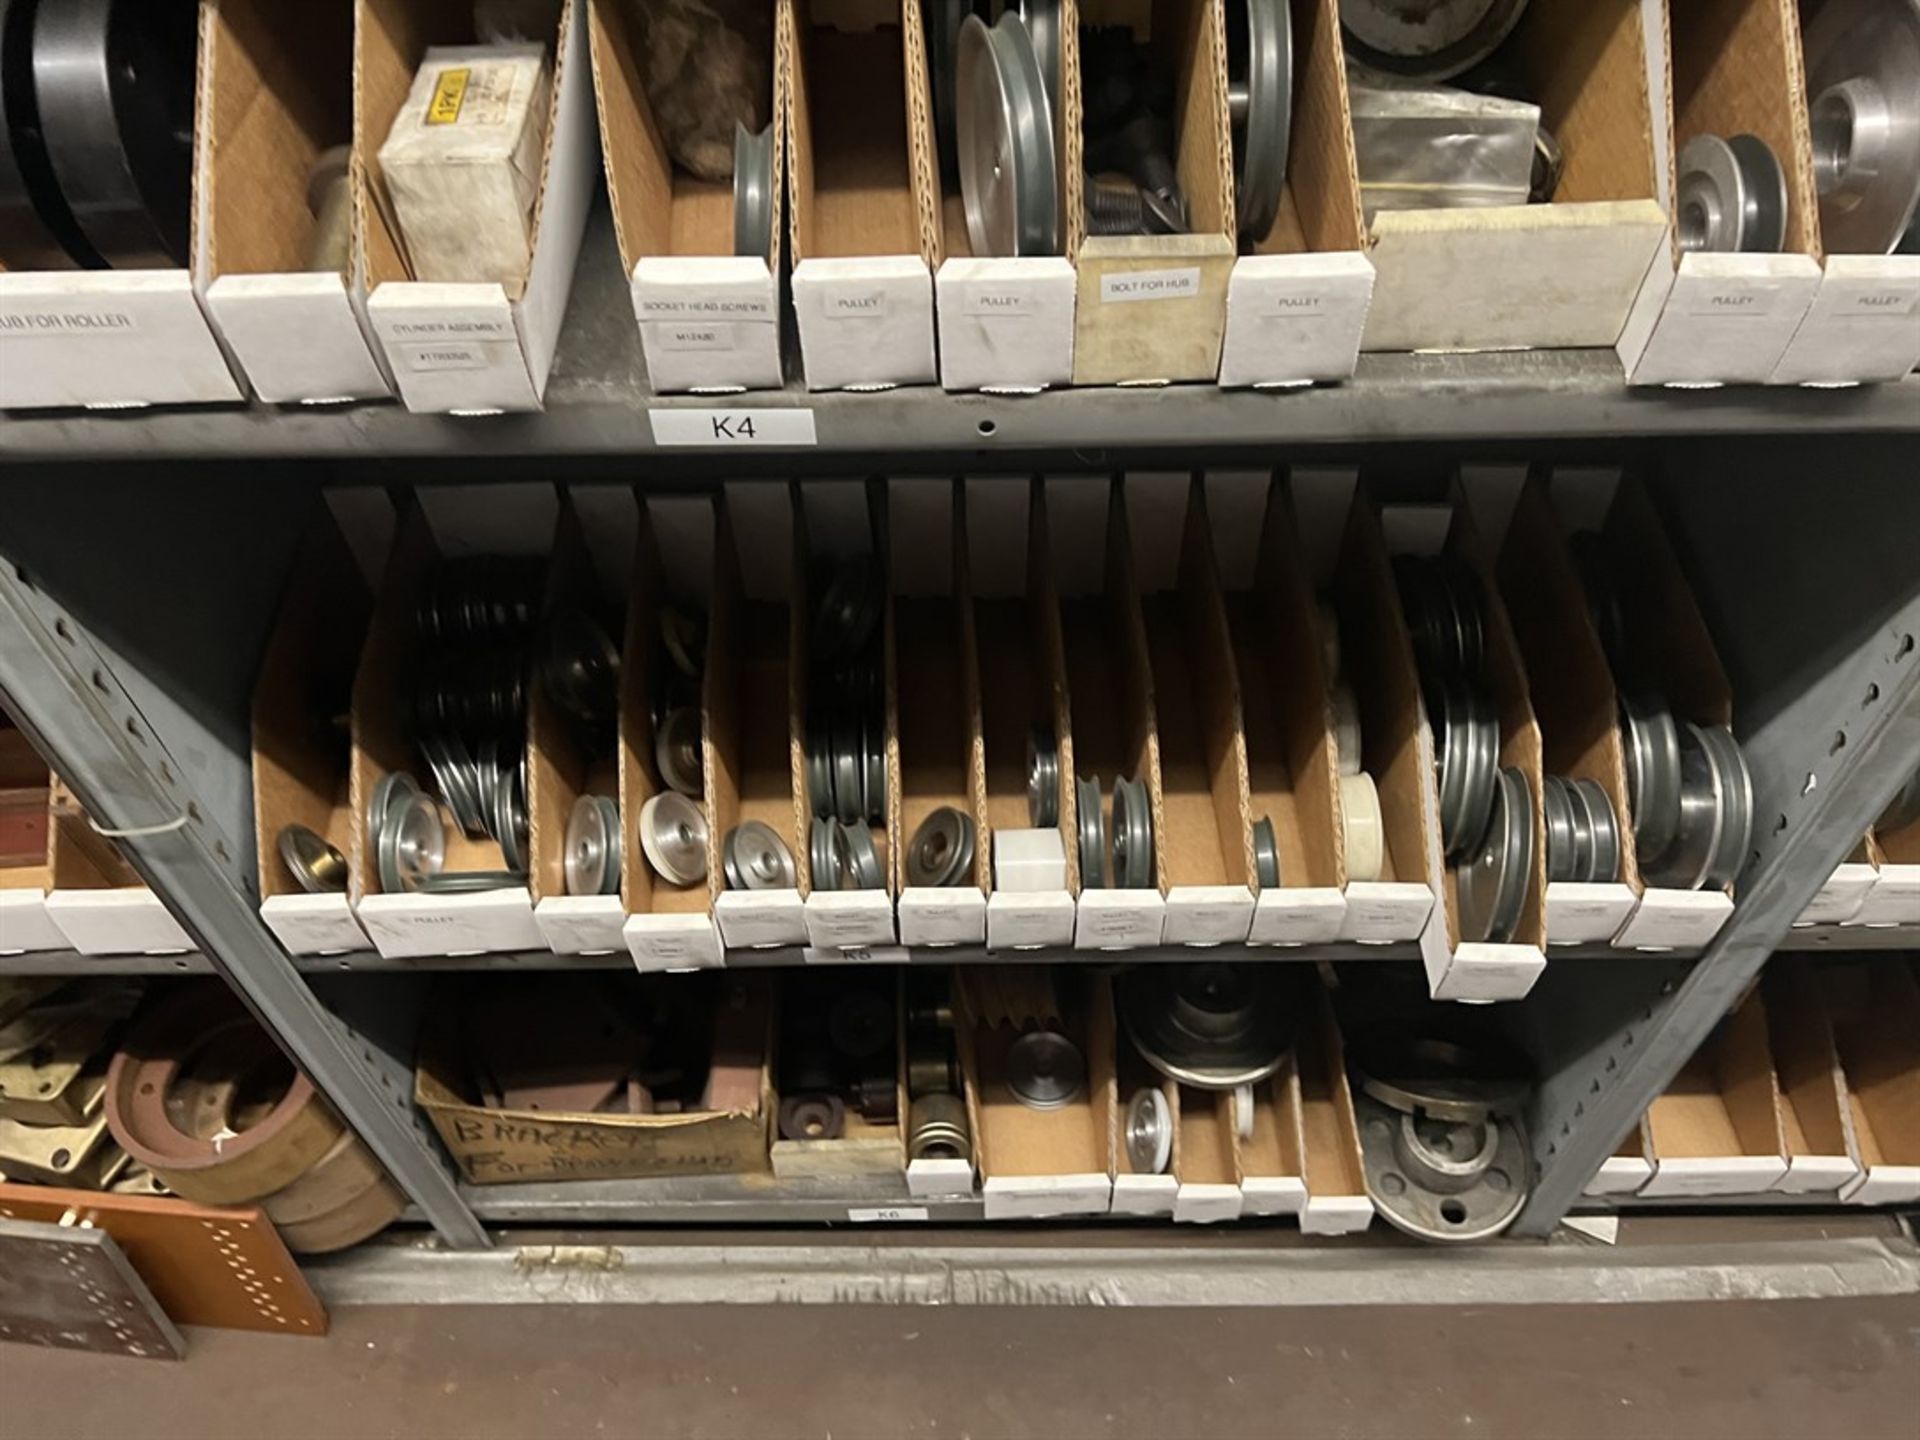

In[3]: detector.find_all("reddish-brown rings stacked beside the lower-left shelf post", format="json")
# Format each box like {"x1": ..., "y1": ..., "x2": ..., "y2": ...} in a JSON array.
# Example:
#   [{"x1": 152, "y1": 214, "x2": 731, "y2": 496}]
[{"x1": 106, "y1": 981, "x2": 407, "y2": 1254}]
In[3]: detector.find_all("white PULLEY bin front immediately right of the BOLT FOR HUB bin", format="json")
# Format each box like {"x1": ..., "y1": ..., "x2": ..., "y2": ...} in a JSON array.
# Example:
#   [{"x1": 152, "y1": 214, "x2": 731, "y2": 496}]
[{"x1": 1219, "y1": 252, "x2": 1373, "y2": 388}]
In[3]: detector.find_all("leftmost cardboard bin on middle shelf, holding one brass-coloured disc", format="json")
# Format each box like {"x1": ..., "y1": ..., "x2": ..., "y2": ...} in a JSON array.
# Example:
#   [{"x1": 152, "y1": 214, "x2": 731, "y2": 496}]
[{"x1": 252, "y1": 511, "x2": 372, "y2": 954}]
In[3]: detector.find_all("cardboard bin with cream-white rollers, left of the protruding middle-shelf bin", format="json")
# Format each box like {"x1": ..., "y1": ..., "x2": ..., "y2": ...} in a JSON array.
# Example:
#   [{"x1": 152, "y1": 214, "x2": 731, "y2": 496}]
[{"x1": 1332, "y1": 492, "x2": 1455, "y2": 948}]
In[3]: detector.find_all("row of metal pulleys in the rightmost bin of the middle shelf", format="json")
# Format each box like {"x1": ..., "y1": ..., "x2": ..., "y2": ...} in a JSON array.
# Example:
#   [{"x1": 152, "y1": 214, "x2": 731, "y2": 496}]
[{"x1": 1574, "y1": 534, "x2": 1753, "y2": 891}]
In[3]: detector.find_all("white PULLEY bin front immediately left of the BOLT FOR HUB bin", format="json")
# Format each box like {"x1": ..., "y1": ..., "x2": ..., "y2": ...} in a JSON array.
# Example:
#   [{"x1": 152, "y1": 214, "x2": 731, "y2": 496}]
[{"x1": 933, "y1": 255, "x2": 1075, "y2": 394}]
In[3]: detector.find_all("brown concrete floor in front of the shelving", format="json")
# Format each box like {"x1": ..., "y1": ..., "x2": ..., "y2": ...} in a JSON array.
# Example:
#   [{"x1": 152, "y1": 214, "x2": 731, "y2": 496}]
[{"x1": 0, "y1": 1294, "x2": 1920, "y2": 1440}]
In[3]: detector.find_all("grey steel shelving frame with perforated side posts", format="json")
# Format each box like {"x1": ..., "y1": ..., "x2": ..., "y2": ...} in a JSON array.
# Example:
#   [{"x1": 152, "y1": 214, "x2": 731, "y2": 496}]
[{"x1": 0, "y1": 214, "x2": 1920, "y2": 1246}]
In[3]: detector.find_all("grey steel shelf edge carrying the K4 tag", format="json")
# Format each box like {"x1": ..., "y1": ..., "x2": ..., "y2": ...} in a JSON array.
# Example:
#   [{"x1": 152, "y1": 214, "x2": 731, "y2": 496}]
[{"x1": 0, "y1": 211, "x2": 1920, "y2": 463}]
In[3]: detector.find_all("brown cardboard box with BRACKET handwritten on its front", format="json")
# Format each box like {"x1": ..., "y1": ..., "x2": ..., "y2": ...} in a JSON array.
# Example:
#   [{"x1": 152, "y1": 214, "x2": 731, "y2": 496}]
[{"x1": 413, "y1": 975, "x2": 772, "y2": 1185}]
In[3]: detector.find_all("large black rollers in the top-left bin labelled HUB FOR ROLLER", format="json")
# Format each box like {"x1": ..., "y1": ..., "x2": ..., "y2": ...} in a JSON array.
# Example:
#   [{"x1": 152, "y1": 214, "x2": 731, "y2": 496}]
[{"x1": 0, "y1": 0, "x2": 198, "y2": 271}]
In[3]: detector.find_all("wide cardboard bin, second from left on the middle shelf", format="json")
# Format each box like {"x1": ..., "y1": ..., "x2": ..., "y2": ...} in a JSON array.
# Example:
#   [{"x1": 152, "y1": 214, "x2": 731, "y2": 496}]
[{"x1": 348, "y1": 484, "x2": 555, "y2": 958}]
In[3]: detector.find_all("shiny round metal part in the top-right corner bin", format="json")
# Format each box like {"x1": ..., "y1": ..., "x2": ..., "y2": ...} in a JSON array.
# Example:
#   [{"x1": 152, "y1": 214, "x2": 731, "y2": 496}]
[{"x1": 1803, "y1": 0, "x2": 1920, "y2": 255}]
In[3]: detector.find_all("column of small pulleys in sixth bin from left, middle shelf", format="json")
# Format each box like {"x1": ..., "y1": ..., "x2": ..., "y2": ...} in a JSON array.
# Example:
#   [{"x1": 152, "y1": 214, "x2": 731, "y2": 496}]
[{"x1": 806, "y1": 555, "x2": 883, "y2": 891}]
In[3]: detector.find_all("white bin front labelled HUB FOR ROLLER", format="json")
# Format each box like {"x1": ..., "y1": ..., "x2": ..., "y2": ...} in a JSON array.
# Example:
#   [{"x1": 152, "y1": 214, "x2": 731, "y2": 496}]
[{"x1": 0, "y1": 271, "x2": 242, "y2": 409}]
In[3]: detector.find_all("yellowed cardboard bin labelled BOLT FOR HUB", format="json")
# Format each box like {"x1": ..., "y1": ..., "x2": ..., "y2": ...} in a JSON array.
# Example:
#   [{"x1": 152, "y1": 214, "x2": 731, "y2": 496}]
[{"x1": 1064, "y1": 0, "x2": 1235, "y2": 386}]
